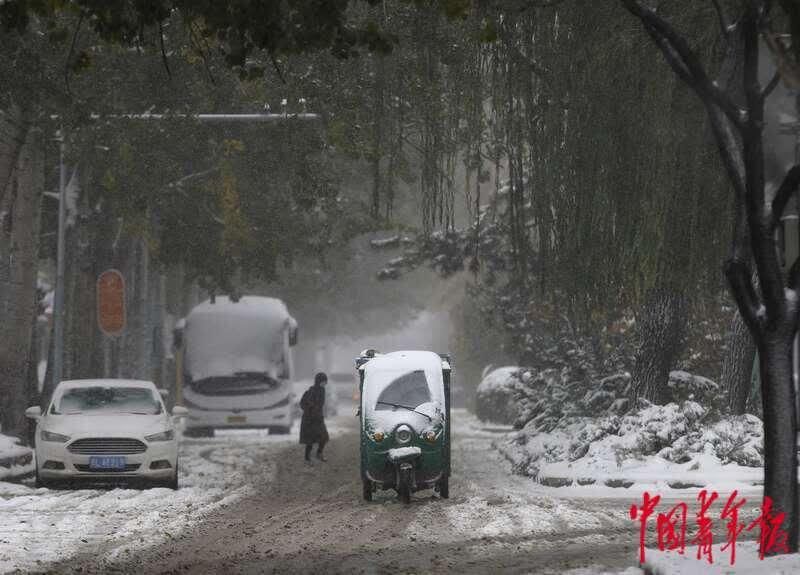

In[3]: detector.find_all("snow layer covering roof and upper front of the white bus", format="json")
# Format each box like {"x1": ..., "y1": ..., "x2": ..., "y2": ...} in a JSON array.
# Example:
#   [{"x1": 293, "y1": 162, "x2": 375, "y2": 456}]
[{"x1": 184, "y1": 296, "x2": 297, "y2": 381}]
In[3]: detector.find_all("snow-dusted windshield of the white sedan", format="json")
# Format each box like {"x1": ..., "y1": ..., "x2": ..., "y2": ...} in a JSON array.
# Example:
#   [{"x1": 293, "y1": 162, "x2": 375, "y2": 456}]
[{"x1": 53, "y1": 386, "x2": 161, "y2": 415}]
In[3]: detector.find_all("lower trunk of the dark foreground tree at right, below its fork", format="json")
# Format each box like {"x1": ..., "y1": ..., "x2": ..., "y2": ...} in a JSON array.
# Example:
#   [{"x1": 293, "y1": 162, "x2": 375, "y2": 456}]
[{"x1": 759, "y1": 338, "x2": 798, "y2": 552}]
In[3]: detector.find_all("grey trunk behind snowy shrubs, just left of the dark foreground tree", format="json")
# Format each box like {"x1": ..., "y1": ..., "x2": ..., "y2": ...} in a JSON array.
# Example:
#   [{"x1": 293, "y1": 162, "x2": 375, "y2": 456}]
[{"x1": 720, "y1": 311, "x2": 756, "y2": 415}]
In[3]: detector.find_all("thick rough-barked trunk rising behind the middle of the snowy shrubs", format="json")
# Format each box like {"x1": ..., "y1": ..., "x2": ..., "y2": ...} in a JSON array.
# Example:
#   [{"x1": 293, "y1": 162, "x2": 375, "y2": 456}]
[{"x1": 630, "y1": 289, "x2": 688, "y2": 406}]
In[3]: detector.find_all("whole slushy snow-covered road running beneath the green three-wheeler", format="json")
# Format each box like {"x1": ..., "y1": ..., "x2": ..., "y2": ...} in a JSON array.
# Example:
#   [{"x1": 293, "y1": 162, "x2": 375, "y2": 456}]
[{"x1": 0, "y1": 408, "x2": 780, "y2": 575}]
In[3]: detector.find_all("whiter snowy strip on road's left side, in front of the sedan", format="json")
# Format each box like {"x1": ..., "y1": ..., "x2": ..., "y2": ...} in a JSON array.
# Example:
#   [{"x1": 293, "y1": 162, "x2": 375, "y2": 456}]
[{"x1": 0, "y1": 430, "x2": 308, "y2": 573}]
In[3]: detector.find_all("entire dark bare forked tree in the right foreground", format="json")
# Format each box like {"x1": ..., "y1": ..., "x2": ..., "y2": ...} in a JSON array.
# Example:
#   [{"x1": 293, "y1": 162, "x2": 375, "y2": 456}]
[{"x1": 621, "y1": 0, "x2": 800, "y2": 552}]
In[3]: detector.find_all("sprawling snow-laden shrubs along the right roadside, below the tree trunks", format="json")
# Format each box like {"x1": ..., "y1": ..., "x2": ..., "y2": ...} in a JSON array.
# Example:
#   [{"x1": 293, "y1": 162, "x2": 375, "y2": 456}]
[{"x1": 497, "y1": 370, "x2": 763, "y2": 484}]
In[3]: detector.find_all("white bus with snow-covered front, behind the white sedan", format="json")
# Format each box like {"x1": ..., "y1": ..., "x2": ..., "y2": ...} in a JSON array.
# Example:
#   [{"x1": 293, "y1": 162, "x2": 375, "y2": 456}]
[{"x1": 182, "y1": 296, "x2": 297, "y2": 436}]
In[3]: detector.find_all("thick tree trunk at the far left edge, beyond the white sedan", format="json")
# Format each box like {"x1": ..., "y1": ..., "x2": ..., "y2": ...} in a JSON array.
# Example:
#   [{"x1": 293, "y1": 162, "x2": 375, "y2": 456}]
[{"x1": 0, "y1": 130, "x2": 44, "y2": 437}]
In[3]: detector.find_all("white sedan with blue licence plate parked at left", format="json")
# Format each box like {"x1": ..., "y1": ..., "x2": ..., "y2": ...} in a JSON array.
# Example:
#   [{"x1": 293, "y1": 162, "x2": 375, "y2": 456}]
[{"x1": 26, "y1": 379, "x2": 186, "y2": 489}]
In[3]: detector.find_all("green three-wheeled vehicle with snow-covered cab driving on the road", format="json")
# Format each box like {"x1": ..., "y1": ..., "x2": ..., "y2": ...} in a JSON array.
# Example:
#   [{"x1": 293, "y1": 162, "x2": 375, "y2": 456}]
[{"x1": 356, "y1": 350, "x2": 452, "y2": 503}]
